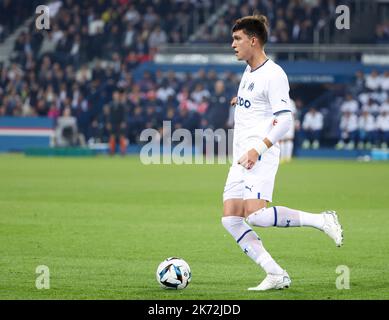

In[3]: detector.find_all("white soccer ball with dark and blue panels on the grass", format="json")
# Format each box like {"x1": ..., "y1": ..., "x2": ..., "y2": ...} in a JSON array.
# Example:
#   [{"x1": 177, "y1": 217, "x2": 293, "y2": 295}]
[{"x1": 156, "y1": 257, "x2": 192, "y2": 290}]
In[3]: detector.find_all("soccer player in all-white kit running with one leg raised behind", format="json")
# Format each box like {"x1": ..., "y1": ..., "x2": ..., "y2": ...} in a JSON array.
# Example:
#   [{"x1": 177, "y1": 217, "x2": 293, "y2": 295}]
[{"x1": 222, "y1": 15, "x2": 343, "y2": 290}]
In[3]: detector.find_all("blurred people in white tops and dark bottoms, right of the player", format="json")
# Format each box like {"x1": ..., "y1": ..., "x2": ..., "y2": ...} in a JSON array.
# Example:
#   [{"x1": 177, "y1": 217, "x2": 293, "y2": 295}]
[{"x1": 302, "y1": 70, "x2": 389, "y2": 150}]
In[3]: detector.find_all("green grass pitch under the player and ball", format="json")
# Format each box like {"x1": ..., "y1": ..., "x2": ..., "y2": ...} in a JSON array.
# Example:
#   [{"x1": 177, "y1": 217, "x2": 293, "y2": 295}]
[{"x1": 0, "y1": 155, "x2": 389, "y2": 300}]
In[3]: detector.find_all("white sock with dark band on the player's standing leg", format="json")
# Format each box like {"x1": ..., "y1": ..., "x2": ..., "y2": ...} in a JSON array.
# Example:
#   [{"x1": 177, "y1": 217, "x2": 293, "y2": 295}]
[{"x1": 222, "y1": 216, "x2": 283, "y2": 274}]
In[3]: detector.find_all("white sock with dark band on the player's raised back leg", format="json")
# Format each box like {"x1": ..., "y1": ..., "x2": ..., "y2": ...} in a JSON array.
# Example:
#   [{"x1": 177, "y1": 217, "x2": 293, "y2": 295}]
[{"x1": 247, "y1": 206, "x2": 324, "y2": 230}]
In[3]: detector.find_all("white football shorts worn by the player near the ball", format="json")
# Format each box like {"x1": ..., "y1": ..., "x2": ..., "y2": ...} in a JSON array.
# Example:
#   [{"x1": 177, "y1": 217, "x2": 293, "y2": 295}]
[{"x1": 223, "y1": 143, "x2": 280, "y2": 202}]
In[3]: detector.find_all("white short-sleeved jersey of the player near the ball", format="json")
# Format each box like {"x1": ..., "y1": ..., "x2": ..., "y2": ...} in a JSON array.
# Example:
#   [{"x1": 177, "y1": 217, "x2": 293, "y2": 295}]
[{"x1": 234, "y1": 59, "x2": 291, "y2": 147}]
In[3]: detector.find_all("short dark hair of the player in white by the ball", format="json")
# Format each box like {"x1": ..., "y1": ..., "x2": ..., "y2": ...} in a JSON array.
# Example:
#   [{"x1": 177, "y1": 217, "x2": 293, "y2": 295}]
[{"x1": 232, "y1": 15, "x2": 269, "y2": 45}]
